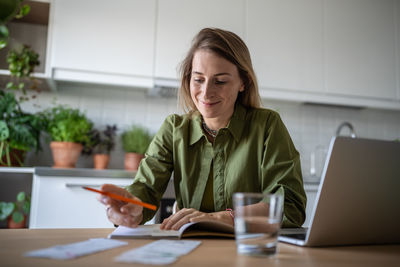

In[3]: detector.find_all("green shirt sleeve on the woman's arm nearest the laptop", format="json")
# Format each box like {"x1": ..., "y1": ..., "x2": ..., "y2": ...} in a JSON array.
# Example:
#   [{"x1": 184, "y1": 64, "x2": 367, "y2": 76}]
[{"x1": 261, "y1": 113, "x2": 307, "y2": 227}]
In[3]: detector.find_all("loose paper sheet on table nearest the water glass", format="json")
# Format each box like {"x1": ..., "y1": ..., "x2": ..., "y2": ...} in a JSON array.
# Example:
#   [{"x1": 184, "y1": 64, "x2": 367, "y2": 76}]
[{"x1": 115, "y1": 240, "x2": 201, "y2": 265}]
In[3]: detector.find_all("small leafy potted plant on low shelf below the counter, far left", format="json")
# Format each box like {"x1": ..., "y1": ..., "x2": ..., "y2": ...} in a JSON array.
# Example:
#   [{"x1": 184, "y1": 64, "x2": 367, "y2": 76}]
[{"x1": 0, "y1": 192, "x2": 31, "y2": 228}]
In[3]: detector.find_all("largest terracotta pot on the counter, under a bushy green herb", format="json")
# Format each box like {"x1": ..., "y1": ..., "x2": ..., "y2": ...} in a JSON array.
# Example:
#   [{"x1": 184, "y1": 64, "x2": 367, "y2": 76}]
[{"x1": 50, "y1": 142, "x2": 83, "y2": 168}]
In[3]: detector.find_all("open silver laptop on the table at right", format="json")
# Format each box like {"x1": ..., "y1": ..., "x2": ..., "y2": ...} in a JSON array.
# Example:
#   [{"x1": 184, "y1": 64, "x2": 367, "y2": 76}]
[{"x1": 279, "y1": 137, "x2": 400, "y2": 246}]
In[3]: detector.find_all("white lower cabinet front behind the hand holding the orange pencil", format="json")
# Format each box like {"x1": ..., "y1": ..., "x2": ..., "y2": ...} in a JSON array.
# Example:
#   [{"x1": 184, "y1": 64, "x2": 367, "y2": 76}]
[{"x1": 29, "y1": 175, "x2": 132, "y2": 228}]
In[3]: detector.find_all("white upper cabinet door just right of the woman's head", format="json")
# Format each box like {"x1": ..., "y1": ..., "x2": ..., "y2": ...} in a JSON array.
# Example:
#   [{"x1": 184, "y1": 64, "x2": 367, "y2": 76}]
[{"x1": 246, "y1": 0, "x2": 323, "y2": 92}]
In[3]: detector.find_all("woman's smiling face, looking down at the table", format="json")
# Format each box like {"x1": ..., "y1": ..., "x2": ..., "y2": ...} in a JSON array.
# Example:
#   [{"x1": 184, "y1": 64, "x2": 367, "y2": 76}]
[{"x1": 190, "y1": 50, "x2": 244, "y2": 122}]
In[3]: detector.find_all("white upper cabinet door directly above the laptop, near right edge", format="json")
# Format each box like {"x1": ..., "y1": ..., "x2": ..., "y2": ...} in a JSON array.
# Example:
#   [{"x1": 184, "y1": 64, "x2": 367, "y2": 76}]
[{"x1": 324, "y1": 0, "x2": 396, "y2": 99}]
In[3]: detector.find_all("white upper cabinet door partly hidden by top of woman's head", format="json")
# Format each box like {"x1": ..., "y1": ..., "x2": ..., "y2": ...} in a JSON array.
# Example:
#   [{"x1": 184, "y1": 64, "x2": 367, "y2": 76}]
[{"x1": 155, "y1": 0, "x2": 245, "y2": 80}]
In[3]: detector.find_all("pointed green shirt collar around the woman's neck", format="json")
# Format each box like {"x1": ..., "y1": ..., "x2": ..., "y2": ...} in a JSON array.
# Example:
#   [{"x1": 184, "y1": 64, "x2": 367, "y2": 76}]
[{"x1": 189, "y1": 103, "x2": 246, "y2": 145}]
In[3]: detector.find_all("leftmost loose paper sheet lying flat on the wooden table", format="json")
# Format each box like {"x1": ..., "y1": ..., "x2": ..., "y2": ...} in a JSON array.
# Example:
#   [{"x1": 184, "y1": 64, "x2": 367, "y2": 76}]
[{"x1": 24, "y1": 238, "x2": 128, "y2": 260}]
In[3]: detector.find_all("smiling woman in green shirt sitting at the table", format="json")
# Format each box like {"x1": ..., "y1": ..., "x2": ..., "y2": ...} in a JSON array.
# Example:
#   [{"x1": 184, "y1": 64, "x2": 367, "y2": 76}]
[{"x1": 99, "y1": 28, "x2": 306, "y2": 230}]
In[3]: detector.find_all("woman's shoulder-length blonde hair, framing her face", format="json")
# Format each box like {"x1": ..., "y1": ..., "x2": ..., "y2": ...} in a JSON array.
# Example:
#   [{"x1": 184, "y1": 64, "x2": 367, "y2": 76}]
[{"x1": 178, "y1": 28, "x2": 261, "y2": 112}]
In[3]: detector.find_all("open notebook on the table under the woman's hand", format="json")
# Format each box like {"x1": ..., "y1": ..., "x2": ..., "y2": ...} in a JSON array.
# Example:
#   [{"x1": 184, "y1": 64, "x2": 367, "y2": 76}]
[{"x1": 108, "y1": 221, "x2": 235, "y2": 239}]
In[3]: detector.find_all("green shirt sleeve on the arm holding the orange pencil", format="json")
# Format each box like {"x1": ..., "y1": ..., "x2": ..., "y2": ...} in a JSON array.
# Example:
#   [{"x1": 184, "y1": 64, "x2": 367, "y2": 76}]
[{"x1": 126, "y1": 115, "x2": 175, "y2": 224}]
